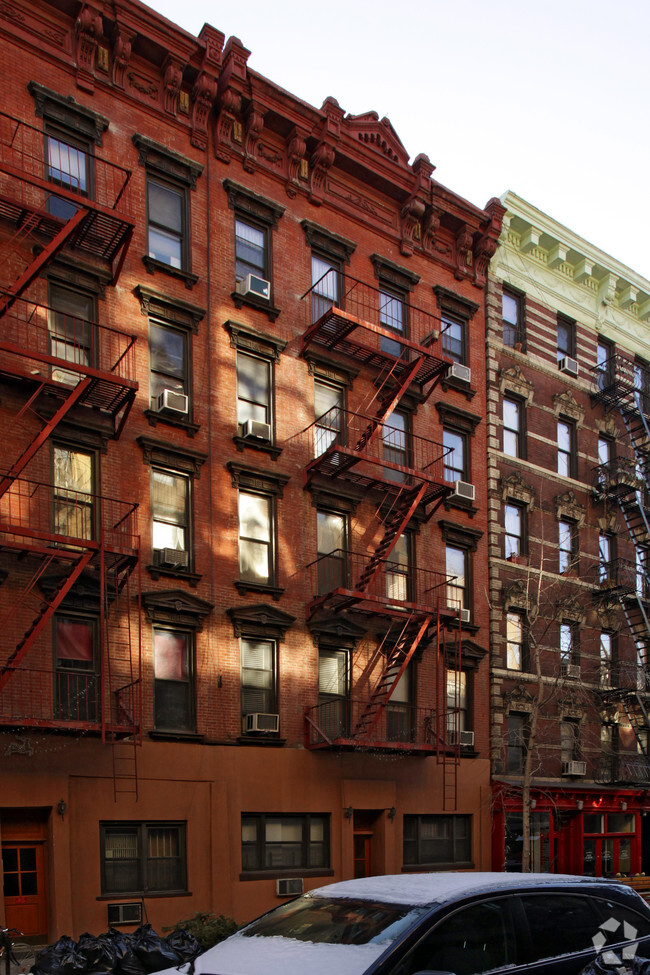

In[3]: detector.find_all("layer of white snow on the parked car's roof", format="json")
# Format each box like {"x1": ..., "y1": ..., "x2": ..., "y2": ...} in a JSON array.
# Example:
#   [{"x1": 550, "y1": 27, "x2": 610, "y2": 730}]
[{"x1": 310, "y1": 872, "x2": 602, "y2": 906}]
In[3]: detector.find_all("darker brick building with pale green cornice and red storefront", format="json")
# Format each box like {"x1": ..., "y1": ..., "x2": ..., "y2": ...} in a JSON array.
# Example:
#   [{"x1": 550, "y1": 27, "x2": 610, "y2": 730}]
[{"x1": 487, "y1": 193, "x2": 650, "y2": 876}]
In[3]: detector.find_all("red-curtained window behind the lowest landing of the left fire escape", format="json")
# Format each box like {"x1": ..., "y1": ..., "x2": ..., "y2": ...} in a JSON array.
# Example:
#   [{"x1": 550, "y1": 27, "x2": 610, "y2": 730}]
[{"x1": 54, "y1": 614, "x2": 101, "y2": 722}]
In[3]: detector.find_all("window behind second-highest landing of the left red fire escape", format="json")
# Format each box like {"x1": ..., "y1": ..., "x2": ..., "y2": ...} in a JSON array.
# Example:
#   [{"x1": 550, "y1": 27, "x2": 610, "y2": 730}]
[{"x1": 48, "y1": 283, "x2": 96, "y2": 386}]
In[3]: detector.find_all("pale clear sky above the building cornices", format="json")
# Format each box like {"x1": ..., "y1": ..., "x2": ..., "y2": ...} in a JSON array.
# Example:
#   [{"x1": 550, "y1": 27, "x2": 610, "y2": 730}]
[{"x1": 150, "y1": 0, "x2": 650, "y2": 279}]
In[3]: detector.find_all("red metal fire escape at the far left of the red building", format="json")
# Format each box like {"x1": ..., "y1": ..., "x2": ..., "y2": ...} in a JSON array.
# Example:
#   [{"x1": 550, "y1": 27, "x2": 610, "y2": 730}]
[{"x1": 0, "y1": 113, "x2": 141, "y2": 794}]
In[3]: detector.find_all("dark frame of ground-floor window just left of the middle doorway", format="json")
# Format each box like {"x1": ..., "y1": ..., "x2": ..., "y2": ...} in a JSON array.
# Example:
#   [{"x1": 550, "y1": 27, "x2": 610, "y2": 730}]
[{"x1": 240, "y1": 812, "x2": 331, "y2": 880}]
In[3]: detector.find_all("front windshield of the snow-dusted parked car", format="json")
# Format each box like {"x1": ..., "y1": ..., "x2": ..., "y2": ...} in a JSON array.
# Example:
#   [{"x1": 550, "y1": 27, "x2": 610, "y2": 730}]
[{"x1": 242, "y1": 894, "x2": 428, "y2": 945}]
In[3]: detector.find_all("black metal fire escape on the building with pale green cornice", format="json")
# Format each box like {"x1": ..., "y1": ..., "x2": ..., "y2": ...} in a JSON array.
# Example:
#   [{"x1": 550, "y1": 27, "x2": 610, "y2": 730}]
[{"x1": 592, "y1": 354, "x2": 650, "y2": 782}]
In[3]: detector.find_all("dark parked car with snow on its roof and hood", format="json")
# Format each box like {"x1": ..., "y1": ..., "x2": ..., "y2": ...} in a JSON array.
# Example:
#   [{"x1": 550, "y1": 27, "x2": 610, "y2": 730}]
[{"x1": 149, "y1": 873, "x2": 650, "y2": 975}]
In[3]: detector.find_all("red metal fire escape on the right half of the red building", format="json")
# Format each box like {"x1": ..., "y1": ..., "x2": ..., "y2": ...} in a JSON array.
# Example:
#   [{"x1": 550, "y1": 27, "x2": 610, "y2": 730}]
[{"x1": 301, "y1": 271, "x2": 461, "y2": 809}]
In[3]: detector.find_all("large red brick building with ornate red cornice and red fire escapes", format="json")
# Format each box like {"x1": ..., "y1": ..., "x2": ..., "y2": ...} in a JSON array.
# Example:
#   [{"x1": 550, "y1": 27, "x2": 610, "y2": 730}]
[{"x1": 0, "y1": 0, "x2": 503, "y2": 938}]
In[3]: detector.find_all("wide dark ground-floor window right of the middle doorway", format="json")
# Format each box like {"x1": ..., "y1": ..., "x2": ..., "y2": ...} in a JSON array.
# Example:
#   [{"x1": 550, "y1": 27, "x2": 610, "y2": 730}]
[{"x1": 403, "y1": 815, "x2": 472, "y2": 866}]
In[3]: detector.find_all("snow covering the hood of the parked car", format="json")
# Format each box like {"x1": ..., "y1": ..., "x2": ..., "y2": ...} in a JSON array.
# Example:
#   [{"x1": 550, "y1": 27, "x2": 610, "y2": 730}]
[{"x1": 149, "y1": 934, "x2": 387, "y2": 975}]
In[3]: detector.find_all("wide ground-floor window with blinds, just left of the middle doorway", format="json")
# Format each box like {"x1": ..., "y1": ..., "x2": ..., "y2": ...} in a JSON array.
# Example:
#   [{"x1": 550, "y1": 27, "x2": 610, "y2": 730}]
[{"x1": 241, "y1": 813, "x2": 330, "y2": 872}]
